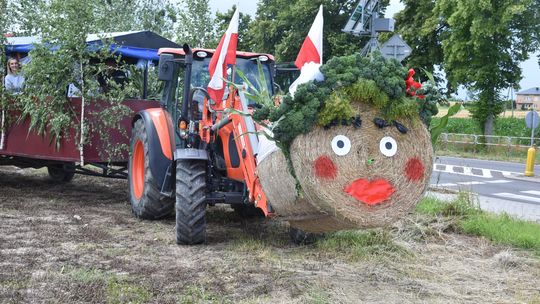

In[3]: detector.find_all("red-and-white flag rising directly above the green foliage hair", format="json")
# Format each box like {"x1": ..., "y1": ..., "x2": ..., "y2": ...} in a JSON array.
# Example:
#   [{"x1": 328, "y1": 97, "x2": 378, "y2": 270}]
[{"x1": 289, "y1": 5, "x2": 324, "y2": 96}]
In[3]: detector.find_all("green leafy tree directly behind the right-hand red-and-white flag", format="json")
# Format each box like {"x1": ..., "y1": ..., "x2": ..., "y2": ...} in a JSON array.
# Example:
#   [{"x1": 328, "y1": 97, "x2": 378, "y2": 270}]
[{"x1": 249, "y1": 0, "x2": 388, "y2": 62}]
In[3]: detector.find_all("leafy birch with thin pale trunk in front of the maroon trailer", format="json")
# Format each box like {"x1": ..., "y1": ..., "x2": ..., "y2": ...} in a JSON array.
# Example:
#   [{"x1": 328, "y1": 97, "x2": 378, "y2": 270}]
[{"x1": 17, "y1": 0, "x2": 131, "y2": 163}]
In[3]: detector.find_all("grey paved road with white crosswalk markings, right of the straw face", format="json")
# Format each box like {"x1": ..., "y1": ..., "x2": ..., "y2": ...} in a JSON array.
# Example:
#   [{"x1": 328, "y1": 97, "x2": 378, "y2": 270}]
[{"x1": 430, "y1": 157, "x2": 540, "y2": 219}]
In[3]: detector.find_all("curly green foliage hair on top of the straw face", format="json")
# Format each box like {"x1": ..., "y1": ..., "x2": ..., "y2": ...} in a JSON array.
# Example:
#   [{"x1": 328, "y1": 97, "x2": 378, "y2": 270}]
[{"x1": 255, "y1": 52, "x2": 430, "y2": 154}]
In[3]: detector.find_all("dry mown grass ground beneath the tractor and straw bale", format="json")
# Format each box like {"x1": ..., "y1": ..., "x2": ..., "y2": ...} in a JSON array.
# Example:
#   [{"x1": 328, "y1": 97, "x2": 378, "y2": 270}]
[{"x1": 0, "y1": 167, "x2": 540, "y2": 303}]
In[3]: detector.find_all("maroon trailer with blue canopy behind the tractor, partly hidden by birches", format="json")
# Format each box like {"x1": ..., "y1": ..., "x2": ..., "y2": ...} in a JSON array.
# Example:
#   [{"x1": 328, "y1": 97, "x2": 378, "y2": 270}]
[{"x1": 0, "y1": 31, "x2": 179, "y2": 182}]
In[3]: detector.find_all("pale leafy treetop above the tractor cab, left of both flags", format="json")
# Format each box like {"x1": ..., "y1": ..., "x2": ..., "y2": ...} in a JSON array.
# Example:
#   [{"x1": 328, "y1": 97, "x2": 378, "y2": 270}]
[{"x1": 176, "y1": 0, "x2": 215, "y2": 48}]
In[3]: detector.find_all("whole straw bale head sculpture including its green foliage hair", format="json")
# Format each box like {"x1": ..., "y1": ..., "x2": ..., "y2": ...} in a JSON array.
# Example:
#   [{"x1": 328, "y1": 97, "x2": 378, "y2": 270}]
[{"x1": 257, "y1": 51, "x2": 433, "y2": 232}]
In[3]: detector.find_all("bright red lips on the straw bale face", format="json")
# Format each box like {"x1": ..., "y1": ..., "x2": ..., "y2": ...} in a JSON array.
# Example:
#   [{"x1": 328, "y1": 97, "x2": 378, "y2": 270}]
[{"x1": 343, "y1": 178, "x2": 396, "y2": 206}]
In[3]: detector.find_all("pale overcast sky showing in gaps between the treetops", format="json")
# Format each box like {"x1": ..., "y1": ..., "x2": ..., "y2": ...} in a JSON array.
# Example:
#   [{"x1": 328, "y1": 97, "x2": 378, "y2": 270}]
[{"x1": 209, "y1": 0, "x2": 540, "y2": 90}]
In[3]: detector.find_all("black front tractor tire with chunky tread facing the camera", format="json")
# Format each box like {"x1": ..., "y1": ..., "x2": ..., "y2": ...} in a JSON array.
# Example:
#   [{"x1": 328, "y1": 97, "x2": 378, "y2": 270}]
[{"x1": 176, "y1": 160, "x2": 206, "y2": 245}]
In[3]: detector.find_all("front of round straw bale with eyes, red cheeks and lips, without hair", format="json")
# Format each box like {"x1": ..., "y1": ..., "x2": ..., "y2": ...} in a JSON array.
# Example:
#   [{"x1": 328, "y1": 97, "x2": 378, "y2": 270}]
[{"x1": 292, "y1": 103, "x2": 433, "y2": 231}]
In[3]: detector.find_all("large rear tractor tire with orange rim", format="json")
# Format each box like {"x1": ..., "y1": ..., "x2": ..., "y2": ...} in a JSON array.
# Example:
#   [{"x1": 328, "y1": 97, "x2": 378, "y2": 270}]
[{"x1": 128, "y1": 119, "x2": 174, "y2": 220}]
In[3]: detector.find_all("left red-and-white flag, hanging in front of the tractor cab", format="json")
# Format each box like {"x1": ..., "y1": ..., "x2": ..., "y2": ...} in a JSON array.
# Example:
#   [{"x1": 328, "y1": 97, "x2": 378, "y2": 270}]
[{"x1": 208, "y1": 8, "x2": 239, "y2": 102}]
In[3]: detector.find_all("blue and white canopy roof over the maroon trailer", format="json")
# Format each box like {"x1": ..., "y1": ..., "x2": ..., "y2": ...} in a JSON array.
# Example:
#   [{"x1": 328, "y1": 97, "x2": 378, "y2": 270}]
[{"x1": 6, "y1": 31, "x2": 180, "y2": 60}]
